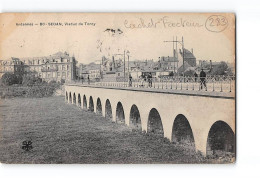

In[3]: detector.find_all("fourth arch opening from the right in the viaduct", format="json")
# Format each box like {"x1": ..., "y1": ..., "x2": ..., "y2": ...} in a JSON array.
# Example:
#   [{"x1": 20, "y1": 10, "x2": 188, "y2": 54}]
[{"x1": 129, "y1": 104, "x2": 142, "y2": 131}]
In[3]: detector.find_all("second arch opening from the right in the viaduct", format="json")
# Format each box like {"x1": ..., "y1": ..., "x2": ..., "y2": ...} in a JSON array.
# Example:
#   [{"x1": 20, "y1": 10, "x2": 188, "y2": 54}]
[{"x1": 172, "y1": 114, "x2": 195, "y2": 150}]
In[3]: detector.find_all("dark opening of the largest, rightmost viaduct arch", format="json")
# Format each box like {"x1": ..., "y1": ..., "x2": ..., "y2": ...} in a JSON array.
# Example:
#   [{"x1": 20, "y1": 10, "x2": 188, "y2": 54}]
[{"x1": 207, "y1": 120, "x2": 236, "y2": 155}]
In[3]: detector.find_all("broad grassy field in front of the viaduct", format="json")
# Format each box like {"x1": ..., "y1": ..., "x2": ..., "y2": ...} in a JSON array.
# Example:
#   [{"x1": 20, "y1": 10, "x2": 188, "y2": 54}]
[{"x1": 0, "y1": 97, "x2": 209, "y2": 164}]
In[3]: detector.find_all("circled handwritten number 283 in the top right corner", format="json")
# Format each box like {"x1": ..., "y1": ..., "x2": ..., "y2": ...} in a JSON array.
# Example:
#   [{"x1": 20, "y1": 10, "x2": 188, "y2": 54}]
[{"x1": 205, "y1": 15, "x2": 228, "y2": 32}]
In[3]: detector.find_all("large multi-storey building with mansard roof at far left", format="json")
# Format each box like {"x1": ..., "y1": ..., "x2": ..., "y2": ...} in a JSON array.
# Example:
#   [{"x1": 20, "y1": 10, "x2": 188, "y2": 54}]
[{"x1": 1, "y1": 52, "x2": 76, "y2": 81}]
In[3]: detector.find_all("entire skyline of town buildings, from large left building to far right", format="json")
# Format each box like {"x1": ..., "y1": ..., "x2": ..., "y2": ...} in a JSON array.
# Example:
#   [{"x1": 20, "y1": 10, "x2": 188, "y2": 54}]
[{"x1": 0, "y1": 49, "x2": 235, "y2": 82}]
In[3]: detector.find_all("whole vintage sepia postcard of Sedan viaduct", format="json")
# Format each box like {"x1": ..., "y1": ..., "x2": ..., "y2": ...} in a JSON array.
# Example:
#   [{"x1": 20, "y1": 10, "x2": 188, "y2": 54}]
[{"x1": 0, "y1": 13, "x2": 236, "y2": 164}]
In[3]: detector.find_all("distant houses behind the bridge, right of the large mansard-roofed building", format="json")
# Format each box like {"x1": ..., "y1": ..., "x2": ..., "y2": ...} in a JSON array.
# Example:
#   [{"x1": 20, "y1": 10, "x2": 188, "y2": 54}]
[{"x1": 79, "y1": 49, "x2": 196, "y2": 81}]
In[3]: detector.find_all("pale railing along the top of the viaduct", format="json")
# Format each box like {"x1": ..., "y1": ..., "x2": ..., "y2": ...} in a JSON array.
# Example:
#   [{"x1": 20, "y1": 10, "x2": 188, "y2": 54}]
[{"x1": 69, "y1": 76, "x2": 235, "y2": 92}]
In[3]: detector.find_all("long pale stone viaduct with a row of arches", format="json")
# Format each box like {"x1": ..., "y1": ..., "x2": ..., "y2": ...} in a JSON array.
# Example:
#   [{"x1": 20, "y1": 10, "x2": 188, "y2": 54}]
[{"x1": 65, "y1": 84, "x2": 236, "y2": 155}]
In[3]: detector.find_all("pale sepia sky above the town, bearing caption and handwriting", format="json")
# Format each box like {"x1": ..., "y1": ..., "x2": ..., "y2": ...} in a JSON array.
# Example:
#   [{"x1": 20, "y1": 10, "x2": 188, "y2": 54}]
[{"x1": 0, "y1": 13, "x2": 235, "y2": 63}]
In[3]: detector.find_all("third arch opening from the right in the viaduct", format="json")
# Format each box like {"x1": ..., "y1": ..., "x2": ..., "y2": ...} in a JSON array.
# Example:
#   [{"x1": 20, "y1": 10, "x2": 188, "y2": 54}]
[{"x1": 147, "y1": 108, "x2": 164, "y2": 137}]
